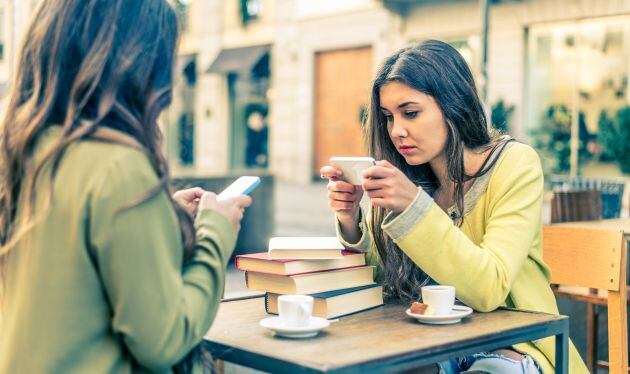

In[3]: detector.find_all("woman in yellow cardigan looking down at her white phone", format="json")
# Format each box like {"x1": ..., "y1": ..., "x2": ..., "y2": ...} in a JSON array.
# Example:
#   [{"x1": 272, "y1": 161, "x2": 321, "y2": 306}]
[{"x1": 321, "y1": 40, "x2": 586, "y2": 373}]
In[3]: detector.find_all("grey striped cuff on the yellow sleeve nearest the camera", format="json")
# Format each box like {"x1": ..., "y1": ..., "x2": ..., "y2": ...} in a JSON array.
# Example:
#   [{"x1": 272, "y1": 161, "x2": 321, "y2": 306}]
[{"x1": 381, "y1": 187, "x2": 433, "y2": 242}]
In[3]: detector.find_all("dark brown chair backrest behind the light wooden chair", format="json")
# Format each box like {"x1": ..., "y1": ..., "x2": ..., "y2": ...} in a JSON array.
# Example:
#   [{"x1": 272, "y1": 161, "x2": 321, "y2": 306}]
[{"x1": 551, "y1": 190, "x2": 602, "y2": 223}]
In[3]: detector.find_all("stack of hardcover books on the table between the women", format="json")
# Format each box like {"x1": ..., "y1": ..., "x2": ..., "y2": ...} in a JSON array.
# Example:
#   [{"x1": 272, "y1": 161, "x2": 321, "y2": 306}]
[{"x1": 235, "y1": 237, "x2": 383, "y2": 318}]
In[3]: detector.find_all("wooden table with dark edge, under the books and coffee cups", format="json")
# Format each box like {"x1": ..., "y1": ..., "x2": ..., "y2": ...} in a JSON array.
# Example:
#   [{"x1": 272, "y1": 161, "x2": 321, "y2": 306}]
[{"x1": 205, "y1": 298, "x2": 569, "y2": 373}]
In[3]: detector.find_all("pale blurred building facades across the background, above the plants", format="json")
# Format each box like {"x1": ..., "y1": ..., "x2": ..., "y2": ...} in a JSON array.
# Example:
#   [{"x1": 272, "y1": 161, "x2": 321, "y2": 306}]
[{"x1": 0, "y1": 0, "x2": 630, "y2": 184}]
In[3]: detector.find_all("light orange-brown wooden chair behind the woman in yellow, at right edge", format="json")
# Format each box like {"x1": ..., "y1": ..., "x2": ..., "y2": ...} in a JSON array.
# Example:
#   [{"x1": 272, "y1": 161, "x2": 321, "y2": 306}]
[{"x1": 543, "y1": 226, "x2": 628, "y2": 374}]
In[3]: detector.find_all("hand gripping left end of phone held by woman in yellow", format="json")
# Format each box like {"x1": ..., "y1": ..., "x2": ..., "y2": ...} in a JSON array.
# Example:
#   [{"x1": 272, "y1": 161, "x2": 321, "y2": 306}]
[{"x1": 319, "y1": 165, "x2": 363, "y2": 224}]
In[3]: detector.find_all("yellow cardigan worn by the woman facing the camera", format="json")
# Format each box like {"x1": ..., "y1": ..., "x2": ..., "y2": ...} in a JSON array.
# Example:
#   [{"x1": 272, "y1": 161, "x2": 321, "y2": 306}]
[{"x1": 337, "y1": 143, "x2": 588, "y2": 373}]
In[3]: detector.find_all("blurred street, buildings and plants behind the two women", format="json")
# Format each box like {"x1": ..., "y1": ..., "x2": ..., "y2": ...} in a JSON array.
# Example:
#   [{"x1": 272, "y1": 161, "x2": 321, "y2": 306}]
[{"x1": 0, "y1": 0, "x2": 630, "y2": 370}]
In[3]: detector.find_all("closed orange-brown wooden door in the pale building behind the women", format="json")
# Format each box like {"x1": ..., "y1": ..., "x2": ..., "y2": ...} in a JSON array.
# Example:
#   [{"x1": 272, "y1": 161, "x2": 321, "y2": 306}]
[{"x1": 313, "y1": 47, "x2": 372, "y2": 178}]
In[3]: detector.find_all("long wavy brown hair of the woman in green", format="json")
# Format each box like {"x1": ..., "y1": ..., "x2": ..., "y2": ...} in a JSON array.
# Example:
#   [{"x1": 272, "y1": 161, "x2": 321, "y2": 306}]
[{"x1": 0, "y1": 0, "x2": 210, "y2": 372}]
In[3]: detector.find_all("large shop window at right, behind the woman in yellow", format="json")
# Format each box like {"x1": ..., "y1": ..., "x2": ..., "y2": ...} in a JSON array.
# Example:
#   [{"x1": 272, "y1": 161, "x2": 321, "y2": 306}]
[{"x1": 525, "y1": 16, "x2": 630, "y2": 172}]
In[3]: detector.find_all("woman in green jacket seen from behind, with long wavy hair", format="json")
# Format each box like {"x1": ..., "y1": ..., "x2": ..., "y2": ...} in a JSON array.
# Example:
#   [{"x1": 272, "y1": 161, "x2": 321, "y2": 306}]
[{"x1": 0, "y1": 0, "x2": 251, "y2": 373}]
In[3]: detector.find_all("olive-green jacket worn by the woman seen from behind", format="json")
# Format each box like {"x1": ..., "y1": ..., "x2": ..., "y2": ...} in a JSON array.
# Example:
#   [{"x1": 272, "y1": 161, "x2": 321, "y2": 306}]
[{"x1": 0, "y1": 127, "x2": 236, "y2": 373}]
